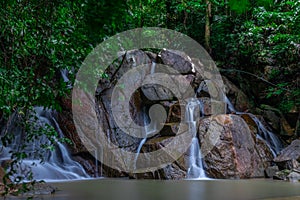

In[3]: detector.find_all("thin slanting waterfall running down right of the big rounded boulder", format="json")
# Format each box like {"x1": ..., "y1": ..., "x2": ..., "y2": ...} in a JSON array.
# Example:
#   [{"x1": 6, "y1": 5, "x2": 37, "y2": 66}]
[{"x1": 225, "y1": 95, "x2": 283, "y2": 156}]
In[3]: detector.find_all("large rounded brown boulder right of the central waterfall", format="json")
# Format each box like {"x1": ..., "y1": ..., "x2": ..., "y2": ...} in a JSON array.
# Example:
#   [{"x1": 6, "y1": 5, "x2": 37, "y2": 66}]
[{"x1": 198, "y1": 115, "x2": 272, "y2": 178}]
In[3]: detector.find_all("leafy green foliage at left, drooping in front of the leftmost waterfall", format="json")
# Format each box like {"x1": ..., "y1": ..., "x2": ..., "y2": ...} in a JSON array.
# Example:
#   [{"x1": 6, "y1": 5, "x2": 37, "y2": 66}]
[{"x1": 0, "y1": 0, "x2": 91, "y2": 194}]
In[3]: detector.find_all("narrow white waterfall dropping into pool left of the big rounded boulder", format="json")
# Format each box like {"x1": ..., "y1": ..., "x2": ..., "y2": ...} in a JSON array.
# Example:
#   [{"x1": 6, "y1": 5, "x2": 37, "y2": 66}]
[{"x1": 185, "y1": 98, "x2": 206, "y2": 179}]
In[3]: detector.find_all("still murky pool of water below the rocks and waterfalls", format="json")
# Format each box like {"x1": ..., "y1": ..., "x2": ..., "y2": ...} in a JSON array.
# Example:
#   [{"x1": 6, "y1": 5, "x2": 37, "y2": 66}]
[{"x1": 9, "y1": 179, "x2": 300, "y2": 200}]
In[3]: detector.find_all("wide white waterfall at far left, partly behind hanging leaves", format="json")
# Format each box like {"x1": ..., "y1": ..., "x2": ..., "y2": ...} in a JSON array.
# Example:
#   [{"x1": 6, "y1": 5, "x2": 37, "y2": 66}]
[{"x1": 0, "y1": 107, "x2": 89, "y2": 181}]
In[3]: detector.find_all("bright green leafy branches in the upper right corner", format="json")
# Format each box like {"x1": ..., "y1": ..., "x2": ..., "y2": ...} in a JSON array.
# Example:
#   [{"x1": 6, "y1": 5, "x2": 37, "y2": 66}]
[{"x1": 229, "y1": 0, "x2": 300, "y2": 112}]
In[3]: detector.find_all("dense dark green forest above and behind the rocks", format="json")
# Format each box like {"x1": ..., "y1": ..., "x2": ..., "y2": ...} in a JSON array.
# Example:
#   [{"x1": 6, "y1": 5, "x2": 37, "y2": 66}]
[{"x1": 0, "y1": 0, "x2": 300, "y2": 116}]
